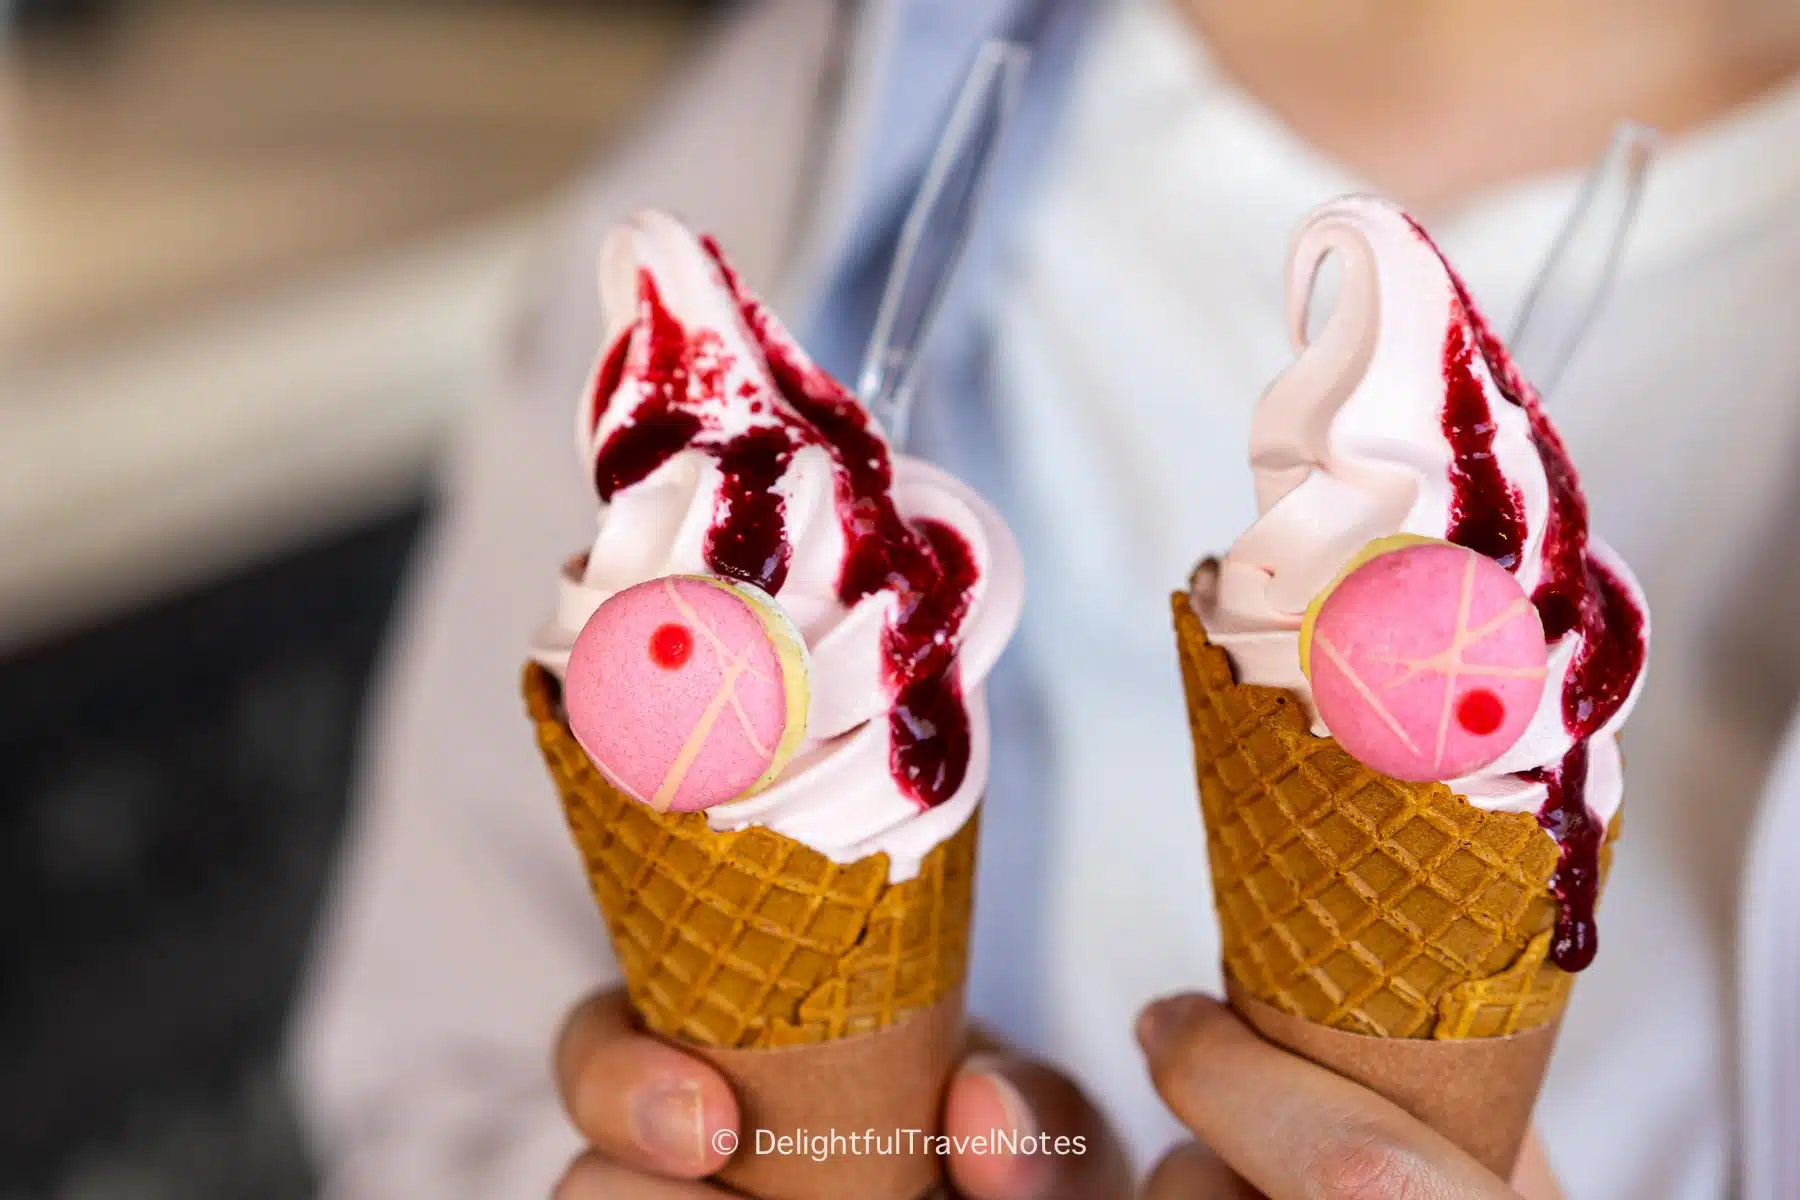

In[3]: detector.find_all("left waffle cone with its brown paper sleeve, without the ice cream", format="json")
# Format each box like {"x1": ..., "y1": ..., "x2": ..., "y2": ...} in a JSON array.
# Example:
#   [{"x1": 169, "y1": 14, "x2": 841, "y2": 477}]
[{"x1": 524, "y1": 664, "x2": 977, "y2": 1200}]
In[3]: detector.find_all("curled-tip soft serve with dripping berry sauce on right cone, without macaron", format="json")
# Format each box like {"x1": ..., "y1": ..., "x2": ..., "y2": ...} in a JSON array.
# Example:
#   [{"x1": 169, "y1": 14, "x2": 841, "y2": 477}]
[{"x1": 1195, "y1": 196, "x2": 1649, "y2": 970}]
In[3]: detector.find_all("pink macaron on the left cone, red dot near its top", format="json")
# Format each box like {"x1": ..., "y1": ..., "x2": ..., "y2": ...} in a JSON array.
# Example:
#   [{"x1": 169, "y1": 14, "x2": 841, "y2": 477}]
[{"x1": 563, "y1": 576, "x2": 808, "y2": 811}]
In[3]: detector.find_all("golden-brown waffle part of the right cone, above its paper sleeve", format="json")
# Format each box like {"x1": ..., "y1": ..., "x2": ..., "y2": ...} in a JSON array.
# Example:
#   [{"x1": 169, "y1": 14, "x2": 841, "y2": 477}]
[{"x1": 1174, "y1": 592, "x2": 1616, "y2": 1040}]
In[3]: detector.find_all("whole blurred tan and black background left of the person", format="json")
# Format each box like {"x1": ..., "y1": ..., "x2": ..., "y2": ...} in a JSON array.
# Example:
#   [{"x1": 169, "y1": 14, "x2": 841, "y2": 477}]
[{"x1": 0, "y1": 0, "x2": 724, "y2": 1200}]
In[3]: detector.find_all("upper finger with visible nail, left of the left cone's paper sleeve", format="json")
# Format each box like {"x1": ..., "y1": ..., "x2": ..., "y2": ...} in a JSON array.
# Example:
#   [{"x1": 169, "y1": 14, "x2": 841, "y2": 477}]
[{"x1": 556, "y1": 991, "x2": 738, "y2": 1178}]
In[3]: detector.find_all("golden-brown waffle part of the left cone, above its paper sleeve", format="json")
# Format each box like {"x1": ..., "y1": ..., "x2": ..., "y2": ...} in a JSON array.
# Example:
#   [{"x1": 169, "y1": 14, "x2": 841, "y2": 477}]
[{"x1": 524, "y1": 664, "x2": 977, "y2": 1049}]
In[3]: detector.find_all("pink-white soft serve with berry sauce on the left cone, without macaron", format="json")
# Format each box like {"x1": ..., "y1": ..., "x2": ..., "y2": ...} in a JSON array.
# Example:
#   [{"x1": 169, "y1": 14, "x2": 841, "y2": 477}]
[{"x1": 533, "y1": 212, "x2": 1024, "y2": 880}]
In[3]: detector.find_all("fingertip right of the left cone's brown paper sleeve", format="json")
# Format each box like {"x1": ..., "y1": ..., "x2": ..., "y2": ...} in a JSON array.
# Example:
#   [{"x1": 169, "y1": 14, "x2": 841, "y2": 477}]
[{"x1": 943, "y1": 1051, "x2": 1130, "y2": 1200}]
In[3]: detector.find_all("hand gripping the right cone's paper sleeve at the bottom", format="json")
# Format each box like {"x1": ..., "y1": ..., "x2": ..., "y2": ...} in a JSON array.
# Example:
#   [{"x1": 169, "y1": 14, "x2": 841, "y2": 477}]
[{"x1": 1138, "y1": 995, "x2": 1559, "y2": 1200}]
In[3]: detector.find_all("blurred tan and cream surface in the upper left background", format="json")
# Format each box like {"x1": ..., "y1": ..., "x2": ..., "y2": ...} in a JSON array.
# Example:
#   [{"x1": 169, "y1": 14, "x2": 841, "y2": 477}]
[{"x1": 0, "y1": 0, "x2": 695, "y2": 648}]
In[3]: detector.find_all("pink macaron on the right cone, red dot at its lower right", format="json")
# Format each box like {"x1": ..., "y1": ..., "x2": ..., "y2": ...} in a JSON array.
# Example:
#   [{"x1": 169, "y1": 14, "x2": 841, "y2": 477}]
[{"x1": 1300, "y1": 534, "x2": 1548, "y2": 783}]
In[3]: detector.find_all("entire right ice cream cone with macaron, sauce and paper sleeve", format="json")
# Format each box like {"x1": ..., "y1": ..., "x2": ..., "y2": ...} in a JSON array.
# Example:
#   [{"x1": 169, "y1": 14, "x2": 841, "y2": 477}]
[{"x1": 1174, "y1": 196, "x2": 1651, "y2": 1175}]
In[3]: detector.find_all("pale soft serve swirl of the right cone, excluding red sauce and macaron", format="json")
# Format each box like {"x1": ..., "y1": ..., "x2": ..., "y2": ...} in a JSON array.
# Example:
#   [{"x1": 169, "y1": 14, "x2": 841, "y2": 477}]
[{"x1": 1195, "y1": 196, "x2": 1649, "y2": 822}]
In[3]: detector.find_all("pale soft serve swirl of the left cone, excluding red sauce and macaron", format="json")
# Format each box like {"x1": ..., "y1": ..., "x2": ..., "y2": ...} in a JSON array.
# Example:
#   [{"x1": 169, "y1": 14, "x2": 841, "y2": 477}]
[{"x1": 533, "y1": 212, "x2": 1024, "y2": 882}]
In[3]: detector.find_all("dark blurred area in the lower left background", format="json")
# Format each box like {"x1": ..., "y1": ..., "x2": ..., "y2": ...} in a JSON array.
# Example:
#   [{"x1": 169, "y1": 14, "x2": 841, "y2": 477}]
[{"x1": 0, "y1": 511, "x2": 419, "y2": 1200}]
